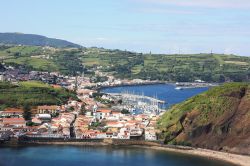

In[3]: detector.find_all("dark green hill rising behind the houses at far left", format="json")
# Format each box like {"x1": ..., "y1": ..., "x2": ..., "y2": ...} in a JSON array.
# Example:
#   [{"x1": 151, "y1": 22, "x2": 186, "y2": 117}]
[{"x1": 0, "y1": 81, "x2": 76, "y2": 110}]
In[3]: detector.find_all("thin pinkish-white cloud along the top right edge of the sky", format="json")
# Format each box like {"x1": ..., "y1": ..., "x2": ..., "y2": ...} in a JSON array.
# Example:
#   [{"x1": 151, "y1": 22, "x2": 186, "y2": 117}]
[{"x1": 137, "y1": 0, "x2": 250, "y2": 9}]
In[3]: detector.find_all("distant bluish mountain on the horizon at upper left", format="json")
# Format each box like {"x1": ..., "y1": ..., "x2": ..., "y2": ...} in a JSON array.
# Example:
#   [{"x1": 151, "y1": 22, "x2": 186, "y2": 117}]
[{"x1": 0, "y1": 33, "x2": 81, "y2": 48}]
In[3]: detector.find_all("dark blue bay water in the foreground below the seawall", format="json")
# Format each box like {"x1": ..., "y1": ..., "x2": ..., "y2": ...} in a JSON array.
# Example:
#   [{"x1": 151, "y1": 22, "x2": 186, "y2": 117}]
[{"x1": 0, "y1": 145, "x2": 233, "y2": 166}]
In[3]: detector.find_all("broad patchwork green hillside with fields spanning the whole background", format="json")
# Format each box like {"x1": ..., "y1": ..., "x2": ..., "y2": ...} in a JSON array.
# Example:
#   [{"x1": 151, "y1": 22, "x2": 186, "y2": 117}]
[{"x1": 0, "y1": 46, "x2": 250, "y2": 82}]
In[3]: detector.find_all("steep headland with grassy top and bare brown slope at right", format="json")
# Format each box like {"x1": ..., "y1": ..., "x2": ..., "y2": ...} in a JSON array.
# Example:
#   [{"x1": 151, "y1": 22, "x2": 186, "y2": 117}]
[{"x1": 158, "y1": 83, "x2": 250, "y2": 155}]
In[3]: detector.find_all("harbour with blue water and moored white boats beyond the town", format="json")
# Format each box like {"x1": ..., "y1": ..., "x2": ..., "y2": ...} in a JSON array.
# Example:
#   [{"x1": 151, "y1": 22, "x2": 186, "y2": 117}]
[{"x1": 101, "y1": 84, "x2": 209, "y2": 109}]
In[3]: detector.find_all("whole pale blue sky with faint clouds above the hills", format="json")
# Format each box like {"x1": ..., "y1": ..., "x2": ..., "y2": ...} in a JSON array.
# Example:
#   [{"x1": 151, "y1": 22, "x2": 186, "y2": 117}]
[{"x1": 0, "y1": 0, "x2": 250, "y2": 56}]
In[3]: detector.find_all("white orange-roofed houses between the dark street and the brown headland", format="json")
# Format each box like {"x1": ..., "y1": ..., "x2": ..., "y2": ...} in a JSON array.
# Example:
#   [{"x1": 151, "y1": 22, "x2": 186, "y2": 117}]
[{"x1": 74, "y1": 109, "x2": 157, "y2": 141}]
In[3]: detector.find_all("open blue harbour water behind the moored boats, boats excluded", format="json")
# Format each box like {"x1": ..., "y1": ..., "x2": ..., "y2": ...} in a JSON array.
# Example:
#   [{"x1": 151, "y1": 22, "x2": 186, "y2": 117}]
[{"x1": 101, "y1": 84, "x2": 209, "y2": 108}]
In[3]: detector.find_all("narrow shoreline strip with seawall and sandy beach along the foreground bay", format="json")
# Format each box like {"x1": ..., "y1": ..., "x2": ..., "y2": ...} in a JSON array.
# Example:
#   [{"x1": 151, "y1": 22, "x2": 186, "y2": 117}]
[{"x1": 0, "y1": 141, "x2": 250, "y2": 166}]
